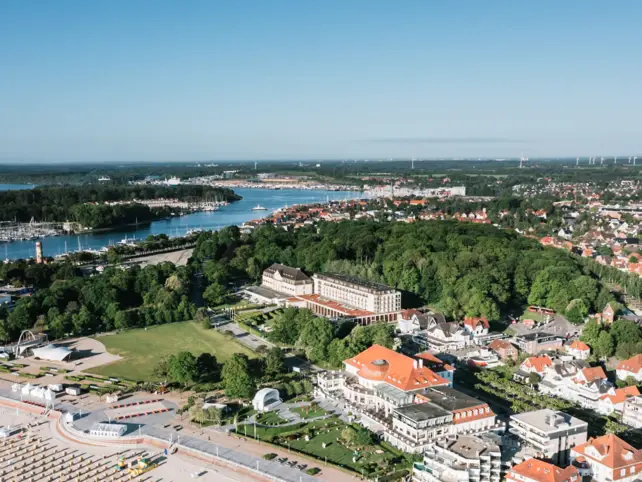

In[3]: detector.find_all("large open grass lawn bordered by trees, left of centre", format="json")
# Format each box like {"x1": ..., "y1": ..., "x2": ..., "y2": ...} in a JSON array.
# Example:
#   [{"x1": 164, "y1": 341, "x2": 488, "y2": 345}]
[{"x1": 88, "y1": 322, "x2": 255, "y2": 381}]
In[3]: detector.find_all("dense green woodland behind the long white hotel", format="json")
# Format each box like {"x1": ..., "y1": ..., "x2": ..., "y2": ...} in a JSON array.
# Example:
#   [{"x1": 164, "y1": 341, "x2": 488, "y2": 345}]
[{"x1": 191, "y1": 221, "x2": 614, "y2": 322}]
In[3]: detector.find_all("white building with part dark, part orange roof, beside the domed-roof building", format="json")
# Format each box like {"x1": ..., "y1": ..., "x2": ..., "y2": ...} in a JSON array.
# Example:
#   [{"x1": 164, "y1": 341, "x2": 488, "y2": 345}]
[{"x1": 383, "y1": 387, "x2": 500, "y2": 453}]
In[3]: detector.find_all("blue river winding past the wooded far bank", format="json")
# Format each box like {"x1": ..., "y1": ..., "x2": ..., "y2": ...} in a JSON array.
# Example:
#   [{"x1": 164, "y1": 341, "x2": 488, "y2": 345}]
[{"x1": 0, "y1": 189, "x2": 362, "y2": 259}]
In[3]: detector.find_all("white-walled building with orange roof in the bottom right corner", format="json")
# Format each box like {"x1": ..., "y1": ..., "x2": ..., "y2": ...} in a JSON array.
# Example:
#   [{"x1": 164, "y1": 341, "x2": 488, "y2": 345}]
[{"x1": 571, "y1": 434, "x2": 642, "y2": 482}]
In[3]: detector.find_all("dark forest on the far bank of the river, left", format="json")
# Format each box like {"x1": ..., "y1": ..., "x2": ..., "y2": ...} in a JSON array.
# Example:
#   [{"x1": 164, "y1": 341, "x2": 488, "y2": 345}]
[{"x1": 0, "y1": 184, "x2": 240, "y2": 228}]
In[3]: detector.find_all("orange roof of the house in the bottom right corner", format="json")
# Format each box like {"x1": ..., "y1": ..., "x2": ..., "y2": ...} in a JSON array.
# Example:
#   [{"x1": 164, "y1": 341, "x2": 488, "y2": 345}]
[{"x1": 573, "y1": 433, "x2": 642, "y2": 472}]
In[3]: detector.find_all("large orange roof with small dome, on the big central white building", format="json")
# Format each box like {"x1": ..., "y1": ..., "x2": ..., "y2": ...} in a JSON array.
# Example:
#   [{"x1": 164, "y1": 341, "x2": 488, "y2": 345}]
[{"x1": 343, "y1": 345, "x2": 449, "y2": 391}]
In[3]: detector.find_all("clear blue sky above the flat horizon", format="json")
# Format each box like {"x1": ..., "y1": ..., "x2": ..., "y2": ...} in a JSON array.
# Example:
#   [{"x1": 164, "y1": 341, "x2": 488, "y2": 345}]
[{"x1": 0, "y1": 0, "x2": 642, "y2": 161}]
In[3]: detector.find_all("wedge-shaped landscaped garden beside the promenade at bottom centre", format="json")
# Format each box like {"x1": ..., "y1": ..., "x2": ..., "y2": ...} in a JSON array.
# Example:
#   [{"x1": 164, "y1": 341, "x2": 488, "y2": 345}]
[{"x1": 238, "y1": 417, "x2": 411, "y2": 477}]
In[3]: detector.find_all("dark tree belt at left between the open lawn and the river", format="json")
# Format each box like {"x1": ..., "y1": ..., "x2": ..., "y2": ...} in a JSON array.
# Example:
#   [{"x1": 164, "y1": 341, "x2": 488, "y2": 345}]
[{"x1": 0, "y1": 261, "x2": 196, "y2": 341}]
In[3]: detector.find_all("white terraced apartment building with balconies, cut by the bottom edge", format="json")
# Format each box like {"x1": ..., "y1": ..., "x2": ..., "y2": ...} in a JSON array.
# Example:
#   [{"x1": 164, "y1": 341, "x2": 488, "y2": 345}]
[{"x1": 412, "y1": 434, "x2": 501, "y2": 482}]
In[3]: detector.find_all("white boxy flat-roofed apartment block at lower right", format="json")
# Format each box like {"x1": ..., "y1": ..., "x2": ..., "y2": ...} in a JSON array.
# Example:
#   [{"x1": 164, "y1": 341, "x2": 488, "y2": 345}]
[{"x1": 509, "y1": 409, "x2": 588, "y2": 465}]
